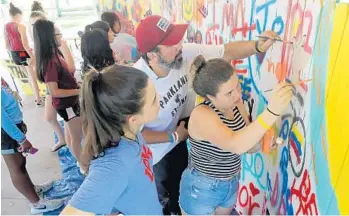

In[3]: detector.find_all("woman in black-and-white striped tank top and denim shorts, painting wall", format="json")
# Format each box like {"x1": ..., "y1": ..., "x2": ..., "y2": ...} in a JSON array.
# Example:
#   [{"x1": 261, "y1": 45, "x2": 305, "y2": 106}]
[{"x1": 179, "y1": 56, "x2": 293, "y2": 215}]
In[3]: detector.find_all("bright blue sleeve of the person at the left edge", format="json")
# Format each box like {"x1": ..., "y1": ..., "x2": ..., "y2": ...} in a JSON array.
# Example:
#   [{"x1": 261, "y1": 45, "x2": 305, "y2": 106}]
[{"x1": 1, "y1": 91, "x2": 25, "y2": 143}]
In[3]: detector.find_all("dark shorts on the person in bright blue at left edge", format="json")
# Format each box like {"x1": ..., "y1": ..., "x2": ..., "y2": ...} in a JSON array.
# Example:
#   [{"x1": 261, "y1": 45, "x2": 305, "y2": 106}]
[{"x1": 1, "y1": 122, "x2": 27, "y2": 155}]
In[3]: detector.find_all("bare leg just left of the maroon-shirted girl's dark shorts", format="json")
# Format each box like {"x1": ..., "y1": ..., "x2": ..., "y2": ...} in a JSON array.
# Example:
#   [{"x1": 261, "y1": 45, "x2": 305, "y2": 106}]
[{"x1": 45, "y1": 95, "x2": 66, "y2": 150}]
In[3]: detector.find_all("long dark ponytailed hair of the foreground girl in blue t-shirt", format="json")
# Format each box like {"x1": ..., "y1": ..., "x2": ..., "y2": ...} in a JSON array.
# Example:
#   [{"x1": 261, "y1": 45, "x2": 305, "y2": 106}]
[{"x1": 81, "y1": 65, "x2": 148, "y2": 163}]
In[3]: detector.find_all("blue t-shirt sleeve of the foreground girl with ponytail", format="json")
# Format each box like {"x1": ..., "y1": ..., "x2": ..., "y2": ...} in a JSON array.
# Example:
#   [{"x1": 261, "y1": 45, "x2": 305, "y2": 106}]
[{"x1": 69, "y1": 158, "x2": 128, "y2": 214}]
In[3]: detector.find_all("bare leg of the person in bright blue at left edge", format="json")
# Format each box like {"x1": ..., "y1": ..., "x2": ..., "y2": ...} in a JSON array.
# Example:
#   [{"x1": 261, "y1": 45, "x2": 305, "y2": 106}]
[{"x1": 3, "y1": 153, "x2": 39, "y2": 203}]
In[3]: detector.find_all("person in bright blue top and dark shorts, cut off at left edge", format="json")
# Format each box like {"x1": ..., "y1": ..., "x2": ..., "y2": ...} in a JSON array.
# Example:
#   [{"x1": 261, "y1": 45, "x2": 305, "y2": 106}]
[{"x1": 1, "y1": 78, "x2": 63, "y2": 214}]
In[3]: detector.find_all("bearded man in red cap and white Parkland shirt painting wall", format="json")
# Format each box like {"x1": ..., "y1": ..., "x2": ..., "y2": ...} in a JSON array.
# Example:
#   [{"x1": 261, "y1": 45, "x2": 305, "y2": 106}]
[{"x1": 134, "y1": 15, "x2": 278, "y2": 214}]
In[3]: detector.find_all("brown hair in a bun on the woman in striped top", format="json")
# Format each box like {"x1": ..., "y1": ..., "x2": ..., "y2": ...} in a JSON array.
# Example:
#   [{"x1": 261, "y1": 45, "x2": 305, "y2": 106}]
[{"x1": 191, "y1": 55, "x2": 234, "y2": 98}]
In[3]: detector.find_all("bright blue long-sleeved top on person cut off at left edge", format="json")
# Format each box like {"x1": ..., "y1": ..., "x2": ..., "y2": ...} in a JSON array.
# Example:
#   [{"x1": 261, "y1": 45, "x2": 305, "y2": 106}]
[{"x1": 1, "y1": 85, "x2": 25, "y2": 144}]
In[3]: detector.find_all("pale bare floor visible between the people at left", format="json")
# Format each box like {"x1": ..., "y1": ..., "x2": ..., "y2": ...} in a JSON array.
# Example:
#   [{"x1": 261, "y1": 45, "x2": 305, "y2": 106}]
[{"x1": 1, "y1": 96, "x2": 61, "y2": 215}]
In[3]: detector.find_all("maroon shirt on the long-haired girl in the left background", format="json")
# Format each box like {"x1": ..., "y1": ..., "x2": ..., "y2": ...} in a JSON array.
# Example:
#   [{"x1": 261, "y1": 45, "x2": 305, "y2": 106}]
[{"x1": 44, "y1": 55, "x2": 79, "y2": 109}]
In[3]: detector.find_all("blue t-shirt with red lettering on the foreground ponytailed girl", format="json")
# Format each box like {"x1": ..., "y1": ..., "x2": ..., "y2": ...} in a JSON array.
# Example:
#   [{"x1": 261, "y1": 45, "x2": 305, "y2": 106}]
[{"x1": 69, "y1": 134, "x2": 162, "y2": 215}]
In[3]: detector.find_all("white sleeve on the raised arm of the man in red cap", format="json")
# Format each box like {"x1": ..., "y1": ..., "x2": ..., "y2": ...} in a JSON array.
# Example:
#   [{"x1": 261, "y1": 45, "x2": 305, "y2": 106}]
[{"x1": 182, "y1": 43, "x2": 224, "y2": 64}]
